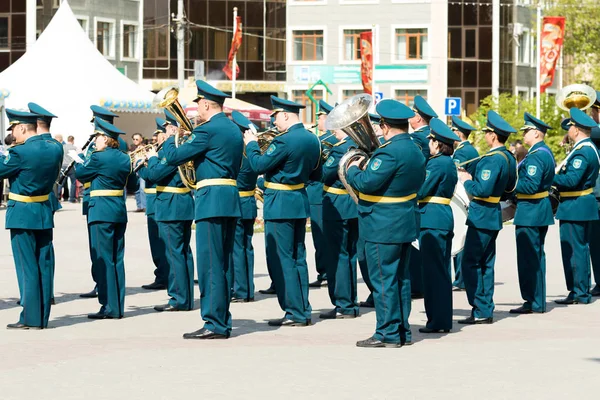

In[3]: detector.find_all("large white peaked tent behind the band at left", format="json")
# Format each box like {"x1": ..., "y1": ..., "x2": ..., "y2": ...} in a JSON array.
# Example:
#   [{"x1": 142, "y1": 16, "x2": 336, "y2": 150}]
[{"x1": 0, "y1": 0, "x2": 156, "y2": 145}]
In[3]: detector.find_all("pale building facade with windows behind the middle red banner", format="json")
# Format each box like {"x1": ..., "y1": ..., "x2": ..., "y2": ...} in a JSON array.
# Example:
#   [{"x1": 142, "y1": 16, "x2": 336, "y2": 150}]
[{"x1": 287, "y1": 0, "x2": 447, "y2": 123}]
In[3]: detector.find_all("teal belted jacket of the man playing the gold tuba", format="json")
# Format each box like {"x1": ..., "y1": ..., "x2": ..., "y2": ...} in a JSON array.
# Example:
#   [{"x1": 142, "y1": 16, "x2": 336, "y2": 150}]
[{"x1": 162, "y1": 113, "x2": 244, "y2": 221}]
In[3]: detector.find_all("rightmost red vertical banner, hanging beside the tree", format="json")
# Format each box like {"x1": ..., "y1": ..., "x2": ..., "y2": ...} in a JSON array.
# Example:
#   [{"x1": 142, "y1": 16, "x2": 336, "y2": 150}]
[{"x1": 540, "y1": 17, "x2": 565, "y2": 93}]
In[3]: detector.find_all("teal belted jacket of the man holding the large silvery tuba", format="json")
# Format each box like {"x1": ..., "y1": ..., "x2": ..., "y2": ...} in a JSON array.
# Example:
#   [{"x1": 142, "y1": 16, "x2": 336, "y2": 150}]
[{"x1": 347, "y1": 134, "x2": 425, "y2": 244}]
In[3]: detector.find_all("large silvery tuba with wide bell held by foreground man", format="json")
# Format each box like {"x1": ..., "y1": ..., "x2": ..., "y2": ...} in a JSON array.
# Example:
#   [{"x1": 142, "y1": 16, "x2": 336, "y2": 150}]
[{"x1": 325, "y1": 93, "x2": 379, "y2": 203}]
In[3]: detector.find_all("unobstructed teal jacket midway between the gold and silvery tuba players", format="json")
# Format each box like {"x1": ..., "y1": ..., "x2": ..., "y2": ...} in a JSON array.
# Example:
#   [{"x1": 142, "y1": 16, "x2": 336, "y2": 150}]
[{"x1": 246, "y1": 123, "x2": 321, "y2": 220}]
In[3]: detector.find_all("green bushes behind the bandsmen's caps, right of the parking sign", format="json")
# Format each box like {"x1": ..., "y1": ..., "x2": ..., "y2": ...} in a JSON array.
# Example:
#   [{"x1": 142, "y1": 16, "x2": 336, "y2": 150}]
[{"x1": 470, "y1": 93, "x2": 567, "y2": 161}]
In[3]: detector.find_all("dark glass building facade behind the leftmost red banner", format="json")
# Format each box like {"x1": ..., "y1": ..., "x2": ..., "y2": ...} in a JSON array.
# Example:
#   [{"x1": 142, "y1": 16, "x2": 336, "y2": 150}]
[{"x1": 143, "y1": 0, "x2": 286, "y2": 107}]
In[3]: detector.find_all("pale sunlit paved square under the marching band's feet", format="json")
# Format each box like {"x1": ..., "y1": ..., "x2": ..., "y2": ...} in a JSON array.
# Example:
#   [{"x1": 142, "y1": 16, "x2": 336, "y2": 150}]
[{"x1": 0, "y1": 199, "x2": 600, "y2": 400}]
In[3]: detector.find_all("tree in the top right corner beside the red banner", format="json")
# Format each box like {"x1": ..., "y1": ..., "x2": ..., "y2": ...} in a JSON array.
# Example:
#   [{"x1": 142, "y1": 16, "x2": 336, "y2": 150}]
[{"x1": 542, "y1": 0, "x2": 600, "y2": 87}]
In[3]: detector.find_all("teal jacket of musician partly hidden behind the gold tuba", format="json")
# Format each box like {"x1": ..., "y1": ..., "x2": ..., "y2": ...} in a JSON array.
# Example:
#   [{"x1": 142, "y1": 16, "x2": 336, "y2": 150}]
[{"x1": 142, "y1": 141, "x2": 194, "y2": 222}]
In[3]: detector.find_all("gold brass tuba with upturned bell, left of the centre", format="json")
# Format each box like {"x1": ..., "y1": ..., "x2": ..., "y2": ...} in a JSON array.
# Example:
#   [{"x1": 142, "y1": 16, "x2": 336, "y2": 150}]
[{"x1": 153, "y1": 86, "x2": 196, "y2": 189}]
